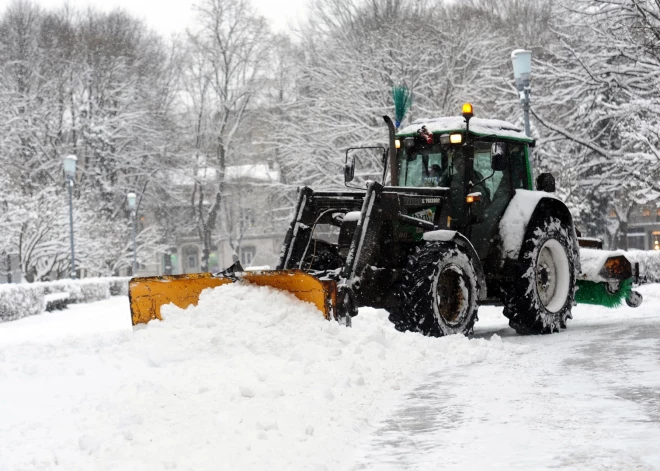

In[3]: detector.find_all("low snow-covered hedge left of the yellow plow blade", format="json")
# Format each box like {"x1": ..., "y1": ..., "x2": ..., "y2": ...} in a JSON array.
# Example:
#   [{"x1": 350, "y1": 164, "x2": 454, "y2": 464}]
[{"x1": 0, "y1": 277, "x2": 130, "y2": 322}]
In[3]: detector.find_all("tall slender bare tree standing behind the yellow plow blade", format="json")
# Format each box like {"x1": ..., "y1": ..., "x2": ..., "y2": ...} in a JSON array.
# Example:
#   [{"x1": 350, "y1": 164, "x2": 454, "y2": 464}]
[{"x1": 183, "y1": 0, "x2": 269, "y2": 270}]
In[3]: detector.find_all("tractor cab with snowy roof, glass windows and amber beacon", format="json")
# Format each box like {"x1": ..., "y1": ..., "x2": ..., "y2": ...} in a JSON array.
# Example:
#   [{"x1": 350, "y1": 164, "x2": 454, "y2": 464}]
[{"x1": 391, "y1": 105, "x2": 534, "y2": 258}]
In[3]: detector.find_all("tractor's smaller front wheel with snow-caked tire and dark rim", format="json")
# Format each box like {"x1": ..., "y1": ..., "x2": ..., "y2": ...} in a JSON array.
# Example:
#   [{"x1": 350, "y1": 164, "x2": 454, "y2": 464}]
[{"x1": 390, "y1": 242, "x2": 479, "y2": 337}]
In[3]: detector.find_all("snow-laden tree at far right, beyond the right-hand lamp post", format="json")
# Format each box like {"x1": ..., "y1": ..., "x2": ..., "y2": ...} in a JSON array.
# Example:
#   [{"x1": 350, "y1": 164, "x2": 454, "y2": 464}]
[{"x1": 533, "y1": 0, "x2": 660, "y2": 248}]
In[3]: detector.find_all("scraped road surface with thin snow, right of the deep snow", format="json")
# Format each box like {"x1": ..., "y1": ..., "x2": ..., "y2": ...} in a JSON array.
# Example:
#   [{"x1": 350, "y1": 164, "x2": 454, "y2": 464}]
[{"x1": 359, "y1": 286, "x2": 660, "y2": 469}]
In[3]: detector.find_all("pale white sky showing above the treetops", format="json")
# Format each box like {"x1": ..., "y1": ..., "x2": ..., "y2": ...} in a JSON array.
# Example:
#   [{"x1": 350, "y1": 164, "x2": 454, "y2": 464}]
[{"x1": 6, "y1": 0, "x2": 307, "y2": 36}]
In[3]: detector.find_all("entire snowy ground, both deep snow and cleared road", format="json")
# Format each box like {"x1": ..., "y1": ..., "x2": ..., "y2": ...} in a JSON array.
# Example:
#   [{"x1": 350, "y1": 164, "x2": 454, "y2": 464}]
[{"x1": 0, "y1": 285, "x2": 660, "y2": 471}]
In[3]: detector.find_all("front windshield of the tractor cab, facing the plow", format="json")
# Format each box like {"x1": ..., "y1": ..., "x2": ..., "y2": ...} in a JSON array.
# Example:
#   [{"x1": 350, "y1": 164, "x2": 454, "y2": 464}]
[{"x1": 397, "y1": 144, "x2": 462, "y2": 187}]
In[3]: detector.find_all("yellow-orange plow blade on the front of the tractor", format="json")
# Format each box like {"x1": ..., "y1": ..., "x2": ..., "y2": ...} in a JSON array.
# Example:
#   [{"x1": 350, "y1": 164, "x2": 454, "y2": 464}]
[{"x1": 128, "y1": 270, "x2": 337, "y2": 325}]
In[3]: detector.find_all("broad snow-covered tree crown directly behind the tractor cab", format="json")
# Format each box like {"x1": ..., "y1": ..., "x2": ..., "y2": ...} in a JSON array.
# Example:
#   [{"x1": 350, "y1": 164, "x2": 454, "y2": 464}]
[{"x1": 279, "y1": 0, "x2": 508, "y2": 192}]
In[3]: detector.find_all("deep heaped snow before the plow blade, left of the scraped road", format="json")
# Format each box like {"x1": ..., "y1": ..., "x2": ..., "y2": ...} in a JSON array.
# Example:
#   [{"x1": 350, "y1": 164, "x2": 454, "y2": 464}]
[{"x1": 0, "y1": 284, "x2": 526, "y2": 470}]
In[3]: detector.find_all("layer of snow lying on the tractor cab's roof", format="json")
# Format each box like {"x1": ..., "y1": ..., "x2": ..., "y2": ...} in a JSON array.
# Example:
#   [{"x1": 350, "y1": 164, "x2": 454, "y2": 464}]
[{"x1": 397, "y1": 116, "x2": 532, "y2": 142}]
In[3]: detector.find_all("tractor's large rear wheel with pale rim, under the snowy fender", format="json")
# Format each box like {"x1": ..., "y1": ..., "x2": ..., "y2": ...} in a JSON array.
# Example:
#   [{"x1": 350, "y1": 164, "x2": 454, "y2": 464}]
[{"x1": 504, "y1": 217, "x2": 578, "y2": 335}]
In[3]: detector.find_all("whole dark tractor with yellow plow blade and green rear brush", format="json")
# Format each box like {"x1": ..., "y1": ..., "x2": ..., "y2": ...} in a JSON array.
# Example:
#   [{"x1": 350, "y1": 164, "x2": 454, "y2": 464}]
[{"x1": 129, "y1": 104, "x2": 642, "y2": 336}]
